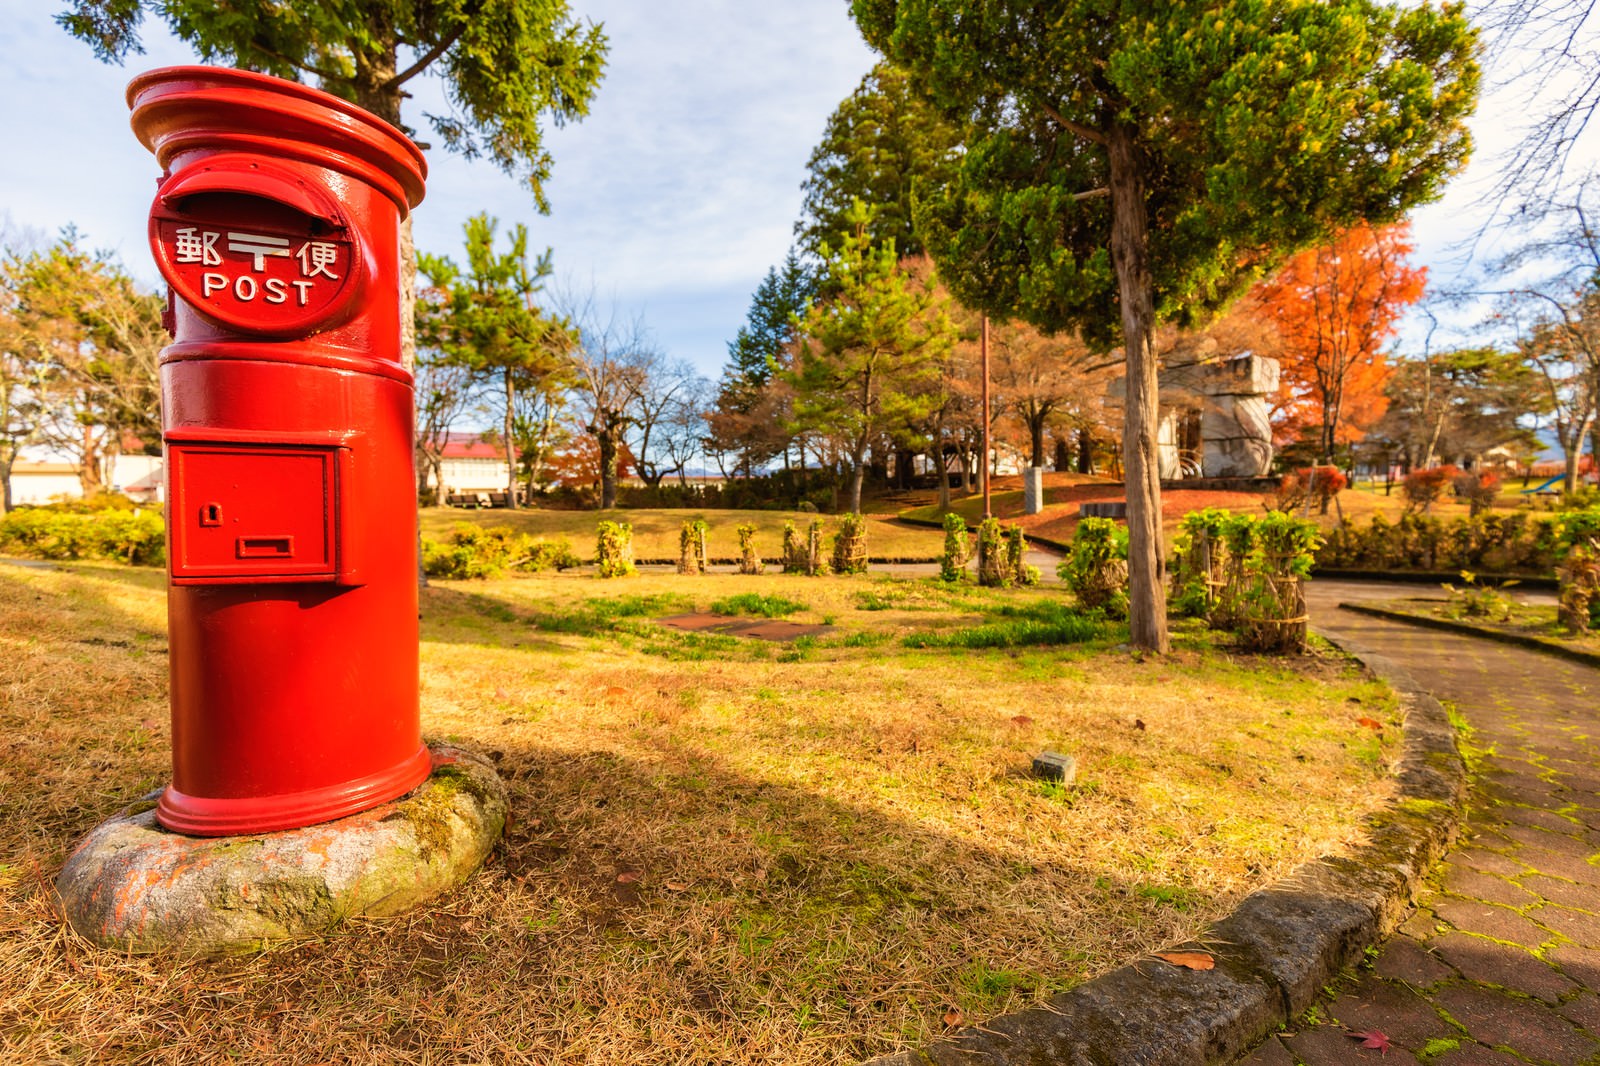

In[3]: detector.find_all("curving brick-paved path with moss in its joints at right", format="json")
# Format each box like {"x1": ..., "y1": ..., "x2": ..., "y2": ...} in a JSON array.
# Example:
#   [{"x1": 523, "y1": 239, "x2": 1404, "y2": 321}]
[{"x1": 1240, "y1": 581, "x2": 1600, "y2": 1066}]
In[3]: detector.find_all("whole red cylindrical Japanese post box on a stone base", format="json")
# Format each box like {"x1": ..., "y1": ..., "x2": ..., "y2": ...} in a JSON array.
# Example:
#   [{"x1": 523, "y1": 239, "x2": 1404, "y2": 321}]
[{"x1": 128, "y1": 67, "x2": 430, "y2": 836}]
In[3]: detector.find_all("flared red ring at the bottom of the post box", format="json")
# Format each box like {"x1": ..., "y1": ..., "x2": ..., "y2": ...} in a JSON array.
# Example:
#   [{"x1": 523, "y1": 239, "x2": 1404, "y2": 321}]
[{"x1": 155, "y1": 746, "x2": 434, "y2": 837}]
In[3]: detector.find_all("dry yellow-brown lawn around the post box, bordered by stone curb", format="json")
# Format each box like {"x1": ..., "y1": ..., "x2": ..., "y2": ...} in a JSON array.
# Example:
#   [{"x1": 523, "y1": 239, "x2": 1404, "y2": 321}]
[{"x1": 0, "y1": 565, "x2": 1395, "y2": 1064}]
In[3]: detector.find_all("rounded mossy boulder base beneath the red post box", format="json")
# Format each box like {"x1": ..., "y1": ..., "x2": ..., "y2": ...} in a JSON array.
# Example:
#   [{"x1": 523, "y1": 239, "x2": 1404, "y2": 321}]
[{"x1": 56, "y1": 746, "x2": 507, "y2": 954}]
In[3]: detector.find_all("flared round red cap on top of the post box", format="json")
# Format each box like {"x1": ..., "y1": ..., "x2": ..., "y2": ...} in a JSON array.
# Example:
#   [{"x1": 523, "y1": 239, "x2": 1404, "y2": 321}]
[{"x1": 128, "y1": 66, "x2": 427, "y2": 216}]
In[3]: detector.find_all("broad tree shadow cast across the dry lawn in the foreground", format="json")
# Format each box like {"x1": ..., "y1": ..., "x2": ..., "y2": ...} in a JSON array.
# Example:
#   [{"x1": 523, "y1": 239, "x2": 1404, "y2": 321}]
[{"x1": 0, "y1": 570, "x2": 1331, "y2": 1063}]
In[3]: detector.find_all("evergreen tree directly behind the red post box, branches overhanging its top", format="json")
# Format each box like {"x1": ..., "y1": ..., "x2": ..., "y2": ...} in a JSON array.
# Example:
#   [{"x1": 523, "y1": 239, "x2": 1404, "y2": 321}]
[{"x1": 56, "y1": 0, "x2": 606, "y2": 367}]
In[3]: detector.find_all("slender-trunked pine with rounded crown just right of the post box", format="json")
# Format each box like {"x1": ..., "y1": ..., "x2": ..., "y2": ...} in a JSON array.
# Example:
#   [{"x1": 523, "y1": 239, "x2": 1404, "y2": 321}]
[{"x1": 418, "y1": 214, "x2": 576, "y2": 507}]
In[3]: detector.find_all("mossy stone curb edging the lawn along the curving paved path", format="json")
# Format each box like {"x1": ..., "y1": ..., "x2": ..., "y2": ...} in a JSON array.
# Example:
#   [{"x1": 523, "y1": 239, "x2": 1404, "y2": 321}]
[{"x1": 867, "y1": 617, "x2": 1467, "y2": 1066}]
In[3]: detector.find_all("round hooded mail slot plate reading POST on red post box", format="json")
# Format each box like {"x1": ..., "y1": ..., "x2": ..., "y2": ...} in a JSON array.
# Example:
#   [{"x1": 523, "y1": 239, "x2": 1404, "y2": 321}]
[{"x1": 150, "y1": 155, "x2": 362, "y2": 336}]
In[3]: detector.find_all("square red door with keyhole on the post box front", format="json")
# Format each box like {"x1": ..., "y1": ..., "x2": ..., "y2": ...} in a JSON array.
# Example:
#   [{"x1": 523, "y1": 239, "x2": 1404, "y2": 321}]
[{"x1": 168, "y1": 443, "x2": 347, "y2": 584}]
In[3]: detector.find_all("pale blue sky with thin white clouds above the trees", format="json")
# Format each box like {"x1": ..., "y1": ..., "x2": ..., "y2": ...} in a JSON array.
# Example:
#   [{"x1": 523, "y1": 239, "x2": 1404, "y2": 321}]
[{"x1": 0, "y1": 0, "x2": 1600, "y2": 378}]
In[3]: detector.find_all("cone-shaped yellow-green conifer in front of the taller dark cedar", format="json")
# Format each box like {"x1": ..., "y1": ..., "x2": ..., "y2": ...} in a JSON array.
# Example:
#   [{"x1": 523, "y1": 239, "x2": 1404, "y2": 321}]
[{"x1": 786, "y1": 200, "x2": 955, "y2": 514}]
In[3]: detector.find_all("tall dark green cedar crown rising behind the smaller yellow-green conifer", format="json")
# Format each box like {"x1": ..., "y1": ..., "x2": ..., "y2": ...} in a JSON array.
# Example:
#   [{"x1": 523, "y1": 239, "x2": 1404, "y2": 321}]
[{"x1": 795, "y1": 62, "x2": 962, "y2": 258}]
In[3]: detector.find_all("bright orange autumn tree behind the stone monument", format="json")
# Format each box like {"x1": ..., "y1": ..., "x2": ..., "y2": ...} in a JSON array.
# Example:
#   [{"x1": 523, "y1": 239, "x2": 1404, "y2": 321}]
[{"x1": 1256, "y1": 222, "x2": 1427, "y2": 463}]
